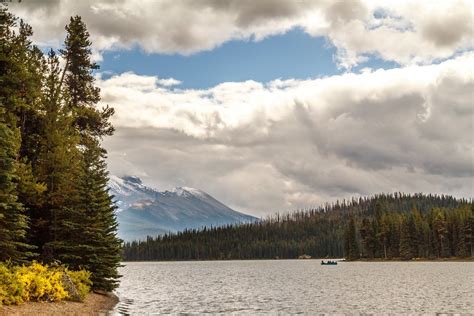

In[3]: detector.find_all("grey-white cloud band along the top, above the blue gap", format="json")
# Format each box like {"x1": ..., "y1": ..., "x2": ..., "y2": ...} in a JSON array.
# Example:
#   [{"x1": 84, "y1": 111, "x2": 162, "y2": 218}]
[{"x1": 10, "y1": 0, "x2": 474, "y2": 68}]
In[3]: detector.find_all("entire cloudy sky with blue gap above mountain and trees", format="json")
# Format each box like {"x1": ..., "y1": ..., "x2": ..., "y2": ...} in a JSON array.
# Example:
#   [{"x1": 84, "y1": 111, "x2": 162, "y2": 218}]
[{"x1": 10, "y1": 0, "x2": 474, "y2": 215}]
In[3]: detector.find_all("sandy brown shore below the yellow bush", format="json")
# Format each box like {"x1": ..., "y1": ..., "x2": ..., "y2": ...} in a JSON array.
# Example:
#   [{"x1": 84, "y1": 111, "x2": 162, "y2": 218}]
[{"x1": 0, "y1": 292, "x2": 119, "y2": 316}]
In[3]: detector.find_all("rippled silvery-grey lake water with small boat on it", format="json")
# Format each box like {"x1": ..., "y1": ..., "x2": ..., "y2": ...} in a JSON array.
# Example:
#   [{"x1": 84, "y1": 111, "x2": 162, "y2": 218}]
[{"x1": 114, "y1": 260, "x2": 474, "y2": 315}]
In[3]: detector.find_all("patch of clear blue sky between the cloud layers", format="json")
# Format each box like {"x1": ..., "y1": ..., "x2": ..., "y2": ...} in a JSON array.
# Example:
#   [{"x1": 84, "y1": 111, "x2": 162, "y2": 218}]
[{"x1": 100, "y1": 29, "x2": 397, "y2": 89}]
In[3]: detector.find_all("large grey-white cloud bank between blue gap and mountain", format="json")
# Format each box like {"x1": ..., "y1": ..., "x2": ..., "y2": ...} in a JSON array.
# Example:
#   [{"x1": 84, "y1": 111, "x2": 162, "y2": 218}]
[{"x1": 98, "y1": 53, "x2": 474, "y2": 214}]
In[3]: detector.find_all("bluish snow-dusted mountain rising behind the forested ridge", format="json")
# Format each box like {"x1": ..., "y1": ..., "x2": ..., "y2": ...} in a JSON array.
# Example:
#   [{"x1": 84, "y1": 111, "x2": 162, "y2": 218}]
[{"x1": 109, "y1": 176, "x2": 257, "y2": 241}]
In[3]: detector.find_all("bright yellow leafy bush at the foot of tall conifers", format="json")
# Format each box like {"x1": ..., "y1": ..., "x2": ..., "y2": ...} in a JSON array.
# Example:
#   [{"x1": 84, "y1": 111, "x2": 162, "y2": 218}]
[{"x1": 0, "y1": 262, "x2": 92, "y2": 305}]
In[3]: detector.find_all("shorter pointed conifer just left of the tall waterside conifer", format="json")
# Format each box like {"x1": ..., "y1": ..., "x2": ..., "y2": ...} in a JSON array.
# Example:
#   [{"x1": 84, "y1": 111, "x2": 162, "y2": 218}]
[{"x1": 35, "y1": 51, "x2": 80, "y2": 262}]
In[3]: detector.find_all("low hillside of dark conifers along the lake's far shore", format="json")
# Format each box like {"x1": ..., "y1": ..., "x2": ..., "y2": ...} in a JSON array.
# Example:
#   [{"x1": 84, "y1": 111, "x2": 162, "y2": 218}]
[{"x1": 124, "y1": 193, "x2": 474, "y2": 261}]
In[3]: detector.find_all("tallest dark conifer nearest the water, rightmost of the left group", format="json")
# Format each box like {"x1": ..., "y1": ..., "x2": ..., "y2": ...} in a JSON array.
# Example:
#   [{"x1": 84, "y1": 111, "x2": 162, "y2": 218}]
[{"x1": 55, "y1": 16, "x2": 121, "y2": 290}]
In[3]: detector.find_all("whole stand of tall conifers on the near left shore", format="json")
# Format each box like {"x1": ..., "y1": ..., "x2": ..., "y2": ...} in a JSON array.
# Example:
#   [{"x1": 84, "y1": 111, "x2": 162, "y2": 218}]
[{"x1": 0, "y1": 5, "x2": 121, "y2": 290}]
